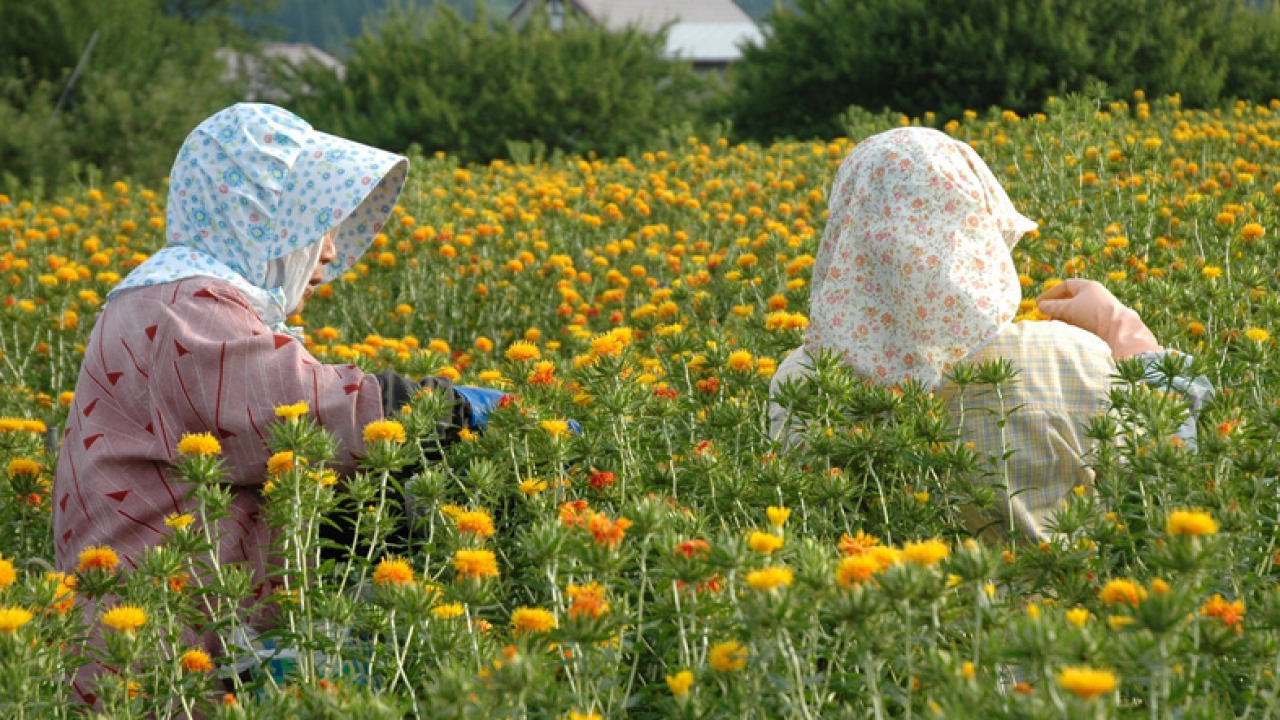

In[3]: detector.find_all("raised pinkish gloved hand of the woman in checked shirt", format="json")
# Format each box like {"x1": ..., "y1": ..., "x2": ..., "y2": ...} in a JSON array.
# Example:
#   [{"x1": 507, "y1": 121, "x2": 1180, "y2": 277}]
[{"x1": 1036, "y1": 278, "x2": 1161, "y2": 360}]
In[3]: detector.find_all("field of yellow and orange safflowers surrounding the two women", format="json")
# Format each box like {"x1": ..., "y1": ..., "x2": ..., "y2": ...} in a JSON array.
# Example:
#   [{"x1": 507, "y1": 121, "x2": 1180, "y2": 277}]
[{"x1": 0, "y1": 94, "x2": 1280, "y2": 719}]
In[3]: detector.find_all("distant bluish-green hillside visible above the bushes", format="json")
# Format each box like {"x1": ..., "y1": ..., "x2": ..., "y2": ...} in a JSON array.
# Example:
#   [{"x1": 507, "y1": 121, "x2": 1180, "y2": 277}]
[{"x1": 255, "y1": 0, "x2": 790, "y2": 55}]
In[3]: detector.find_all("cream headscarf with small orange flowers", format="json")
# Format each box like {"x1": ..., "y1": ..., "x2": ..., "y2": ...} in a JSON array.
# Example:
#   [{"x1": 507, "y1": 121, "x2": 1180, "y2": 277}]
[{"x1": 805, "y1": 128, "x2": 1036, "y2": 388}]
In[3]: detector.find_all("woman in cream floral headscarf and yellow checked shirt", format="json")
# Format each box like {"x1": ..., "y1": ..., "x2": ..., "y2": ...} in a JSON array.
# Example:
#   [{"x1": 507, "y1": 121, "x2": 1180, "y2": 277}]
[{"x1": 771, "y1": 128, "x2": 1210, "y2": 539}]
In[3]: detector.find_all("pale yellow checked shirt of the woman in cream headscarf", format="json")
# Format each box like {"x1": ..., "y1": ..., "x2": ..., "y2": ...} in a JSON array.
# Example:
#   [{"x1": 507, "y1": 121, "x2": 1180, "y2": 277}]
[{"x1": 771, "y1": 322, "x2": 1115, "y2": 539}]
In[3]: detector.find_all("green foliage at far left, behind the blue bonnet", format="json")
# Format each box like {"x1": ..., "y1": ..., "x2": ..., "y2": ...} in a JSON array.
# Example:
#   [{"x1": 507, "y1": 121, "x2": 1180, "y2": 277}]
[{"x1": 0, "y1": 0, "x2": 248, "y2": 192}]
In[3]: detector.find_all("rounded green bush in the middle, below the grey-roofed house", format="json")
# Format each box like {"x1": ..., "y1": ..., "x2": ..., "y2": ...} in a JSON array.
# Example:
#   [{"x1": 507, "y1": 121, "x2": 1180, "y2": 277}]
[{"x1": 293, "y1": 5, "x2": 701, "y2": 160}]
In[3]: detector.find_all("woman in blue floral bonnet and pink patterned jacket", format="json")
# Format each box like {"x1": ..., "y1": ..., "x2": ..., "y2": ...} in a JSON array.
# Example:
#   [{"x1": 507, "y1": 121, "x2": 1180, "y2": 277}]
[{"x1": 54, "y1": 104, "x2": 493, "y2": 703}]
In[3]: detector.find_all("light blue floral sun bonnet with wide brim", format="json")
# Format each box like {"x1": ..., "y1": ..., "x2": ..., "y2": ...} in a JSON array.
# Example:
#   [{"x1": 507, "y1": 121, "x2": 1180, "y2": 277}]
[{"x1": 108, "y1": 102, "x2": 408, "y2": 327}]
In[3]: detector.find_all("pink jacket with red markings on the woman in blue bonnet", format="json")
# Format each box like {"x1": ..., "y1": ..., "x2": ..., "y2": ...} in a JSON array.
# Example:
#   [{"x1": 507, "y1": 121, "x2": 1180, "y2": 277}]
[{"x1": 54, "y1": 277, "x2": 383, "y2": 702}]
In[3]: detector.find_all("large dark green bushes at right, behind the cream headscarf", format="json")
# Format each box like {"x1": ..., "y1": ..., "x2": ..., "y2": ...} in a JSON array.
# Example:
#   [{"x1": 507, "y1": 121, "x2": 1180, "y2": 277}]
[{"x1": 727, "y1": 0, "x2": 1280, "y2": 140}]
